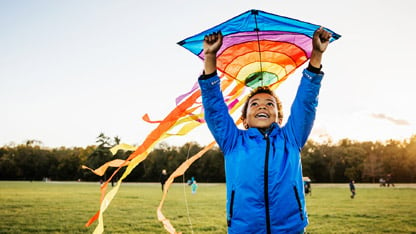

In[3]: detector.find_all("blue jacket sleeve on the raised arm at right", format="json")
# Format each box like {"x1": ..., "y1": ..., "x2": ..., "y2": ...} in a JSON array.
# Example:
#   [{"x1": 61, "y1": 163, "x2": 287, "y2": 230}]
[{"x1": 284, "y1": 69, "x2": 323, "y2": 151}]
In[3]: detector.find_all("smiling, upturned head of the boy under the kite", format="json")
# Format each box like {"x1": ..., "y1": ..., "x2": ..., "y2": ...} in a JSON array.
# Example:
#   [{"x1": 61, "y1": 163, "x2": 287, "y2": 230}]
[{"x1": 243, "y1": 93, "x2": 278, "y2": 129}]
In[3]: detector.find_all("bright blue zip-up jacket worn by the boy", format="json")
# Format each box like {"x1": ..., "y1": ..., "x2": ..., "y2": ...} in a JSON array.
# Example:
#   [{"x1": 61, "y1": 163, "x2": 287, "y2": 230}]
[{"x1": 199, "y1": 69, "x2": 323, "y2": 233}]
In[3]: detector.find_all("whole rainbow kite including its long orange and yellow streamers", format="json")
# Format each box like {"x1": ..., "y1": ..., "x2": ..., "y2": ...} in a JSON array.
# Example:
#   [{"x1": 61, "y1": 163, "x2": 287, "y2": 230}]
[{"x1": 83, "y1": 10, "x2": 341, "y2": 233}]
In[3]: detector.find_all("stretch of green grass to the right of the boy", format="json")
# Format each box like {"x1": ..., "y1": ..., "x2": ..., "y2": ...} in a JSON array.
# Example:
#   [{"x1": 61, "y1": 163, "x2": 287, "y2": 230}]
[{"x1": 307, "y1": 184, "x2": 416, "y2": 233}]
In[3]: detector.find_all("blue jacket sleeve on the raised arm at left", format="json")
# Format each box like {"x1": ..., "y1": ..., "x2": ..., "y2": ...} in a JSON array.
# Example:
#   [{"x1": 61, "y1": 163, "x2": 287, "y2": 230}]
[{"x1": 198, "y1": 75, "x2": 238, "y2": 153}]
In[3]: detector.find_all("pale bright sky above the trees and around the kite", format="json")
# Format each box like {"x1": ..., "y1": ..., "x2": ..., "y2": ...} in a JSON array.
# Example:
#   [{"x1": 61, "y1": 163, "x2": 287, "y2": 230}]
[{"x1": 0, "y1": 0, "x2": 416, "y2": 147}]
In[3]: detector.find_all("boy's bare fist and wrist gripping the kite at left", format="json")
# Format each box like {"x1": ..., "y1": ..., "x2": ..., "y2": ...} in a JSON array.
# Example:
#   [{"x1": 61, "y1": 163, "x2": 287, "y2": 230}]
[{"x1": 204, "y1": 32, "x2": 222, "y2": 75}]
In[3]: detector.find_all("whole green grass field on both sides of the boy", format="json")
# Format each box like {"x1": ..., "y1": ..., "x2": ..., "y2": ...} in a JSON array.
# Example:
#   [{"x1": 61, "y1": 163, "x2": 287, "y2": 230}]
[{"x1": 0, "y1": 181, "x2": 416, "y2": 233}]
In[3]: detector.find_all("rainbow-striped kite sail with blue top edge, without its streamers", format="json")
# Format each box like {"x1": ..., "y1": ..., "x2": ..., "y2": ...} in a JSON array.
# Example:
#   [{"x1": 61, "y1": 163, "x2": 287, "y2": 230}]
[{"x1": 178, "y1": 10, "x2": 341, "y2": 88}]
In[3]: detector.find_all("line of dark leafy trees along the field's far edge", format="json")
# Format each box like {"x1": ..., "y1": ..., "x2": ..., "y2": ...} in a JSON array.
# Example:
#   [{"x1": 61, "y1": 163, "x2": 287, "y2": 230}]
[{"x1": 0, "y1": 134, "x2": 416, "y2": 183}]
